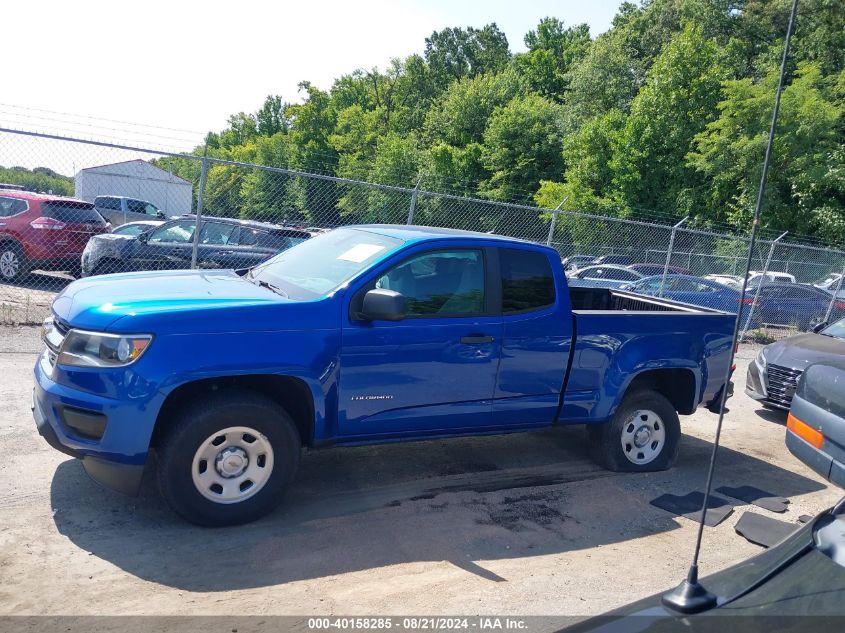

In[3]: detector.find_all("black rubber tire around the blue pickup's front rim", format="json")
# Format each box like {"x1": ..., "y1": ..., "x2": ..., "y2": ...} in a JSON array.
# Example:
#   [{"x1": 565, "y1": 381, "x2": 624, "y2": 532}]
[{"x1": 158, "y1": 389, "x2": 301, "y2": 527}]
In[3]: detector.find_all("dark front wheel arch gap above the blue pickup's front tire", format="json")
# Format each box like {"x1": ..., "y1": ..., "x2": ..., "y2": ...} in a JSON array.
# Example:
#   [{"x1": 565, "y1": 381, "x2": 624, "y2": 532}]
[{"x1": 150, "y1": 374, "x2": 322, "y2": 448}]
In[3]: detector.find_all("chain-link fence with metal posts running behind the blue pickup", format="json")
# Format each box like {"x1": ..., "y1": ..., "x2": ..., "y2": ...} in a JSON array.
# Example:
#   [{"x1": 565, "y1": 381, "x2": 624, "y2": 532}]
[{"x1": 0, "y1": 128, "x2": 845, "y2": 338}]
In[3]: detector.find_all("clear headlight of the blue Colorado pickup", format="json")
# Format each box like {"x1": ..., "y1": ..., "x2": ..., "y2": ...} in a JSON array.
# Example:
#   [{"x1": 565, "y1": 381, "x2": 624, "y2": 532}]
[{"x1": 56, "y1": 330, "x2": 153, "y2": 367}]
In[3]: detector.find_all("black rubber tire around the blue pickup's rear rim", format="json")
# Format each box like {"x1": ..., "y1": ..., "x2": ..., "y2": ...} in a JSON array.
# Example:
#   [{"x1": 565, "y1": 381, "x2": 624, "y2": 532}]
[{"x1": 588, "y1": 389, "x2": 681, "y2": 472}]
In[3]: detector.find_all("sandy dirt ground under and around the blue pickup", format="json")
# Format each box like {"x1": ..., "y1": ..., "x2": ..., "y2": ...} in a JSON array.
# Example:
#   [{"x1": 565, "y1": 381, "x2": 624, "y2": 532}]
[{"x1": 0, "y1": 327, "x2": 842, "y2": 615}]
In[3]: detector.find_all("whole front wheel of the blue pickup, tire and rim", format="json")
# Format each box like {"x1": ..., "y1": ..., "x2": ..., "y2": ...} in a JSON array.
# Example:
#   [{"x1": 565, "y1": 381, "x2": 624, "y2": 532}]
[{"x1": 158, "y1": 390, "x2": 301, "y2": 526}]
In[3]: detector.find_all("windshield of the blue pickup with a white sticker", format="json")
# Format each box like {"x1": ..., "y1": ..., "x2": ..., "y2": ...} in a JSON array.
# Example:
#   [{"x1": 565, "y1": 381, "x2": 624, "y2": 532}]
[{"x1": 248, "y1": 229, "x2": 402, "y2": 301}]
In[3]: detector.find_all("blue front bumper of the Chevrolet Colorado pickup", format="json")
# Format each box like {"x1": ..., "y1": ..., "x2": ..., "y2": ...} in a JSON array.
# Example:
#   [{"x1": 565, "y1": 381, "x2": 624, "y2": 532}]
[{"x1": 32, "y1": 355, "x2": 146, "y2": 495}]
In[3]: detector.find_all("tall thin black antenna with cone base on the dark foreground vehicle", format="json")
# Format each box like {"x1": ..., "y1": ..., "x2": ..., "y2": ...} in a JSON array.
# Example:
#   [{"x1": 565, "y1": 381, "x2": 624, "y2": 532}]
[{"x1": 662, "y1": 0, "x2": 798, "y2": 613}]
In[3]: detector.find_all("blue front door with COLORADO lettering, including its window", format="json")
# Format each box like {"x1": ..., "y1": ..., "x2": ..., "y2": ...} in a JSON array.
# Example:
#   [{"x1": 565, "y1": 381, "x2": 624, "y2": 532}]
[{"x1": 339, "y1": 248, "x2": 502, "y2": 439}]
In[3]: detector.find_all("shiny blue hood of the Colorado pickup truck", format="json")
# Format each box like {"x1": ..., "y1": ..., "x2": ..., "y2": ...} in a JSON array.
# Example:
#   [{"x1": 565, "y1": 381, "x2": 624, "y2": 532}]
[{"x1": 53, "y1": 270, "x2": 290, "y2": 331}]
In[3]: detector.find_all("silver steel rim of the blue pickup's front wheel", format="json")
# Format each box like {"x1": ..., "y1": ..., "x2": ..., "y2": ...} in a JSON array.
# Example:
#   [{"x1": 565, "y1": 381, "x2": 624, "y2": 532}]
[{"x1": 191, "y1": 426, "x2": 273, "y2": 504}]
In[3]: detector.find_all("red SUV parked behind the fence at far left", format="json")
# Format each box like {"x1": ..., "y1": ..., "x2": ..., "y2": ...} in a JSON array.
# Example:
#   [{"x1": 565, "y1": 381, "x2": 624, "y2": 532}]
[{"x1": 0, "y1": 189, "x2": 111, "y2": 282}]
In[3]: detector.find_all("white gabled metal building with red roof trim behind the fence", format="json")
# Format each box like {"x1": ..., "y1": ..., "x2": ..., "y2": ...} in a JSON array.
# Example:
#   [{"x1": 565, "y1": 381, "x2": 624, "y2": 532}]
[{"x1": 75, "y1": 159, "x2": 193, "y2": 216}]
